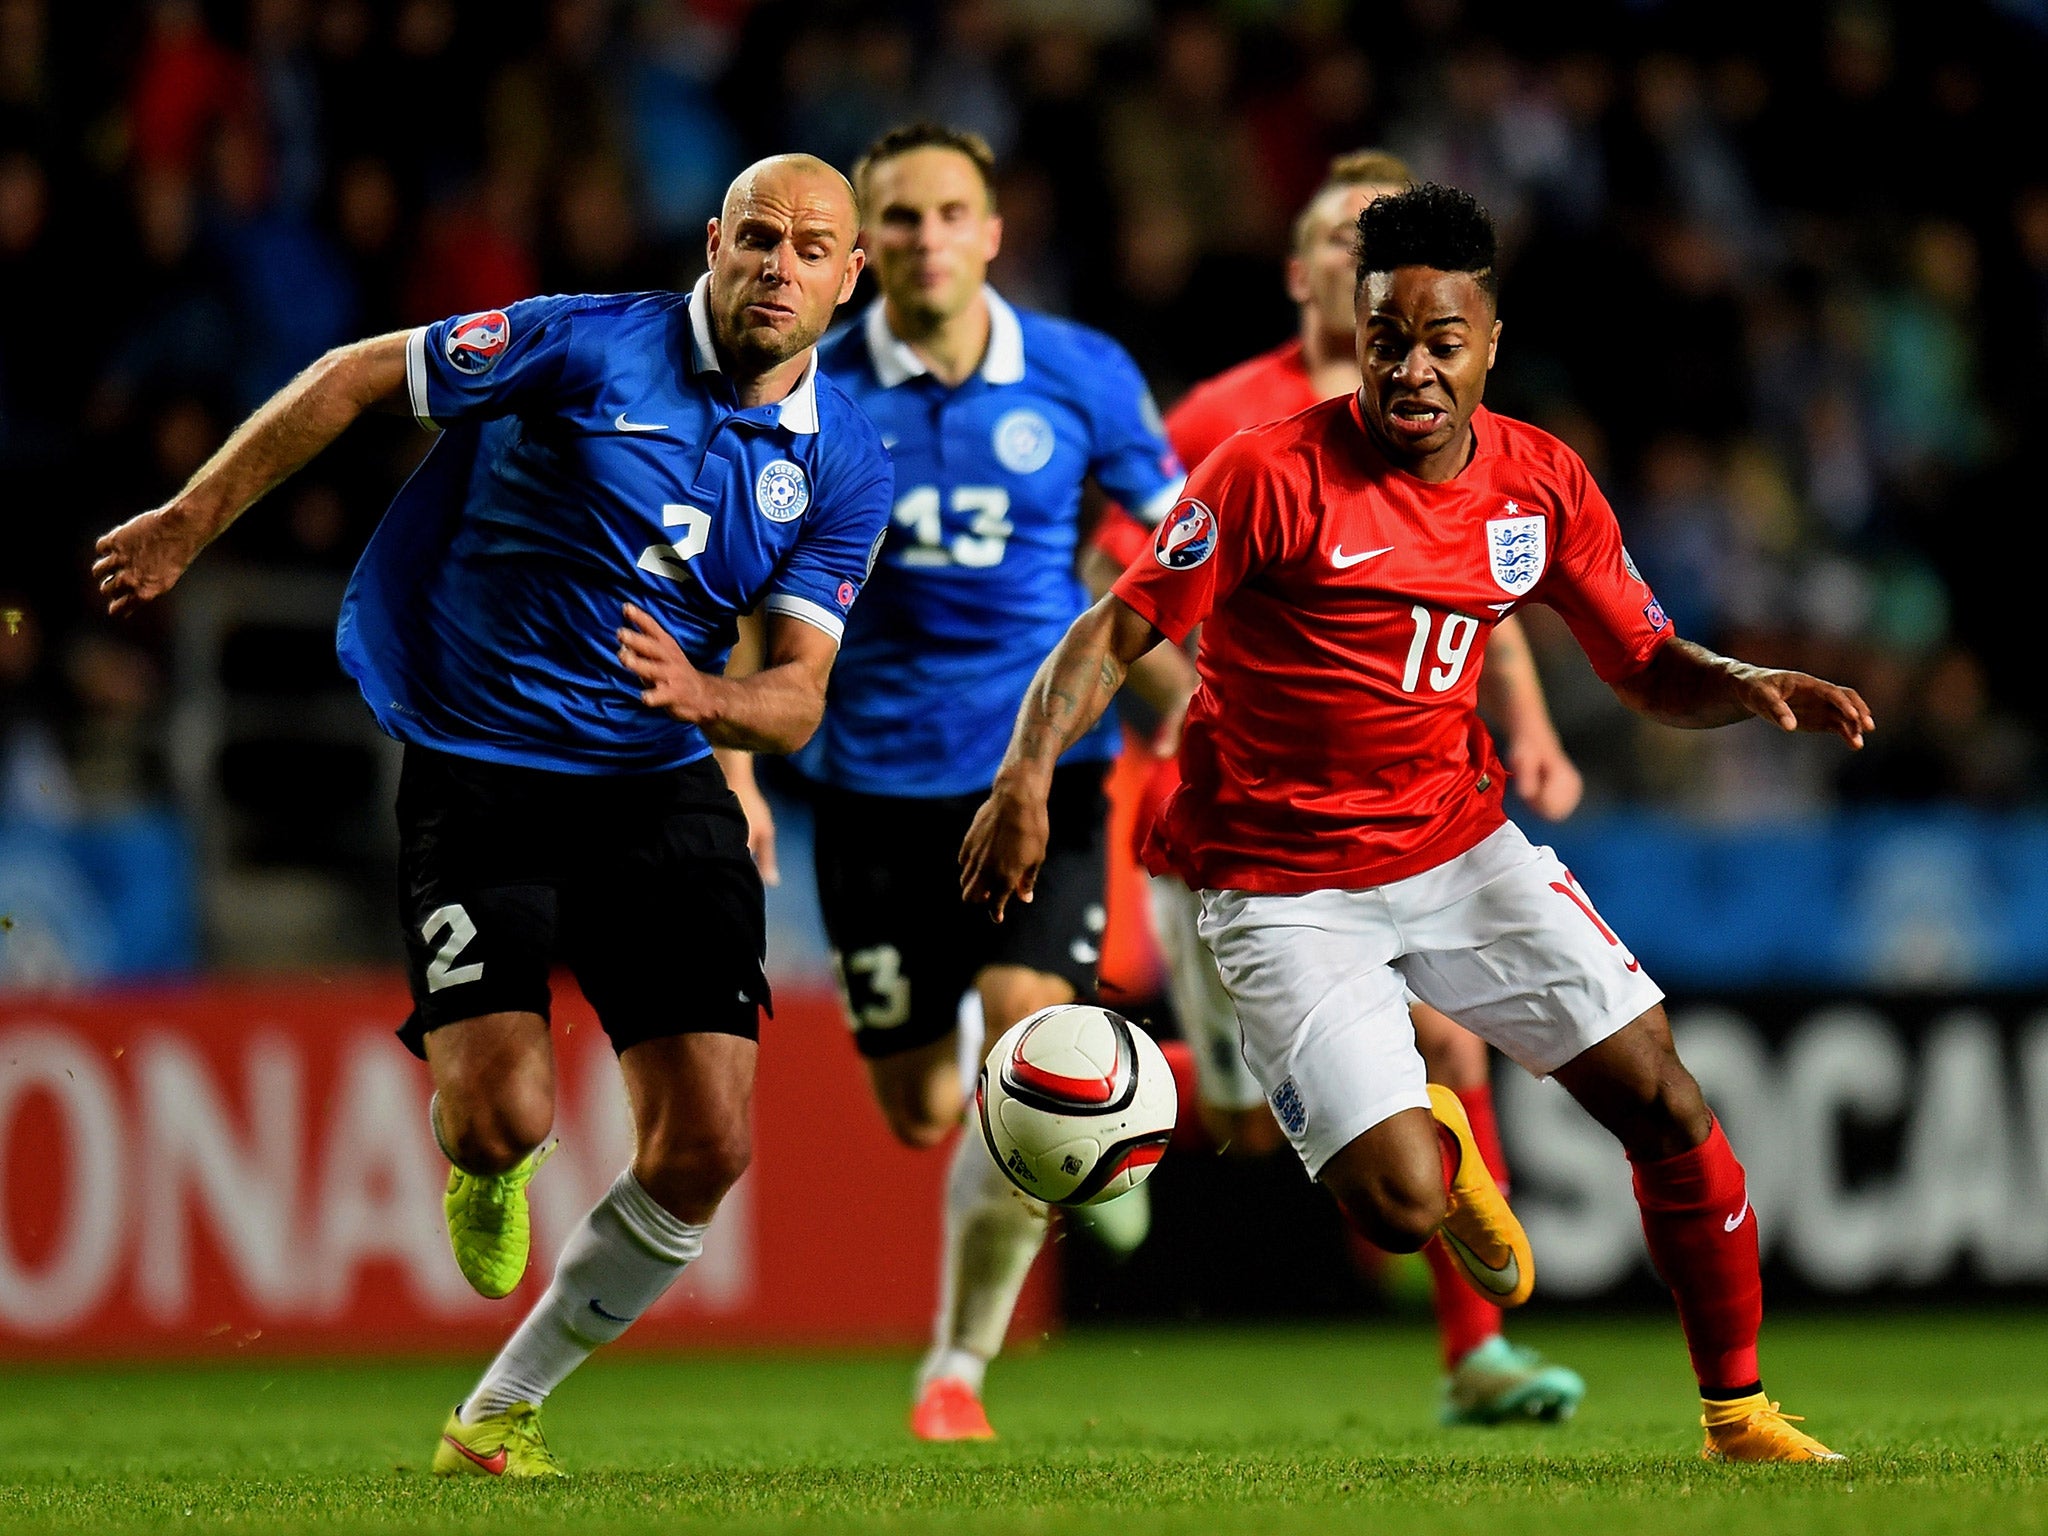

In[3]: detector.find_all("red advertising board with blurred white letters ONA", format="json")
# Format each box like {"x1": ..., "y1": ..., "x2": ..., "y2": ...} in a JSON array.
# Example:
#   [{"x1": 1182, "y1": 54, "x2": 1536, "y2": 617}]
[{"x1": 0, "y1": 977, "x2": 1051, "y2": 1358}]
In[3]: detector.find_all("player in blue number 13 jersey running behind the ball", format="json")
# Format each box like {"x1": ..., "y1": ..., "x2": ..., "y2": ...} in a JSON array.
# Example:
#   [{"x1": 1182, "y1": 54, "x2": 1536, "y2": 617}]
[{"x1": 803, "y1": 125, "x2": 1182, "y2": 1440}]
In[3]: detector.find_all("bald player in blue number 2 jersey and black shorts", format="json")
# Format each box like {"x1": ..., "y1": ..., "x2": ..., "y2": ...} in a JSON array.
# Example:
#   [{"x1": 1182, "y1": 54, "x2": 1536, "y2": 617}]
[{"x1": 94, "y1": 156, "x2": 891, "y2": 1477}]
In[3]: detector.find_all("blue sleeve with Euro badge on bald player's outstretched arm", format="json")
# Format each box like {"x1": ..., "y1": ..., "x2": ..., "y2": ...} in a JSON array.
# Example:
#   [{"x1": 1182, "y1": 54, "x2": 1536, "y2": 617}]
[{"x1": 406, "y1": 297, "x2": 575, "y2": 426}]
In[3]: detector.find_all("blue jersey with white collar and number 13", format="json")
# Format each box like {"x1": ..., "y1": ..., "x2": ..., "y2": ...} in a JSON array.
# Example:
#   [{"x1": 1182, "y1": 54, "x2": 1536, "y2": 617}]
[{"x1": 799, "y1": 289, "x2": 1184, "y2": 797}]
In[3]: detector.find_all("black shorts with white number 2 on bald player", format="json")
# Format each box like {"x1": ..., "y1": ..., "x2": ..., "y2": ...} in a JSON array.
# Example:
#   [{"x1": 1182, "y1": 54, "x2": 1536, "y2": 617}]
[{"x1": 397, "y1": 745, "x2": 772, "y2": 1057}]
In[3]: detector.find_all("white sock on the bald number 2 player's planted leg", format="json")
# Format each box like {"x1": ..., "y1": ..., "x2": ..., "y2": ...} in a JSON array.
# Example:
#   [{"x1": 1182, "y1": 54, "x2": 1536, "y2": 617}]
[{"x1": 463, "y1": 1167, "x2": 709, "y2": 1423}]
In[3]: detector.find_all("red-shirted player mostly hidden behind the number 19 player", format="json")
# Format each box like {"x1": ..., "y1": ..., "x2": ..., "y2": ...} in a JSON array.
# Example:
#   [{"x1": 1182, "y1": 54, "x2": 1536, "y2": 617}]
[{"x1": 1087, "y1": 150, "x2": 1585, "y2": 1423}]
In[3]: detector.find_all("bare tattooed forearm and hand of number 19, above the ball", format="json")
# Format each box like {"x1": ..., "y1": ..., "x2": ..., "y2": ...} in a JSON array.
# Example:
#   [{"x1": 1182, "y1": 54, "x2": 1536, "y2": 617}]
[{"x1": 961, "y1": 592, "x2": 1165, "y2": 922}]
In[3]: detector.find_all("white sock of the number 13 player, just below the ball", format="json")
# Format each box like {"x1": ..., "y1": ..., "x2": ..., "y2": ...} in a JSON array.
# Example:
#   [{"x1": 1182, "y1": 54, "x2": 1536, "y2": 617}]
[{"x1": 918, "y1": 1120, "x2": 1051, "y2": 1395}]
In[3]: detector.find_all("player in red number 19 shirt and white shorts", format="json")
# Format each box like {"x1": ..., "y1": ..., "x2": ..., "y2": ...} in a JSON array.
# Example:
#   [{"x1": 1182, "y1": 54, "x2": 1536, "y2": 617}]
[{"x1": 961, "y1": 186, "x2": 1872, "y2": 1462}]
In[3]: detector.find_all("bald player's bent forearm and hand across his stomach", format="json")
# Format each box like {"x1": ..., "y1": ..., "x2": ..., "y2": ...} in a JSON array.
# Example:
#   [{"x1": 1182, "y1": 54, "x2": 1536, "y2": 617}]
[{"x1": 618, "y1": 602, "x2": 840, "y2": 752}]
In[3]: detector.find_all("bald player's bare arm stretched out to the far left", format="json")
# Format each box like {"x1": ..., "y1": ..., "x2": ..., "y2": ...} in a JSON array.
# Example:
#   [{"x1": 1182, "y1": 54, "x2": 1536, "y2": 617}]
[{"x1": 92, "y1": 332, "x2": 406, "y2": 614}]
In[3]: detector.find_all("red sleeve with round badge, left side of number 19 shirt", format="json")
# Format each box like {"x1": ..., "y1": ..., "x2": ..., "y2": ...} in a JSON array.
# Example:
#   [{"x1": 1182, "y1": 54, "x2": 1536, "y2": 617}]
[{"x1": 1112, "y1": 436, "x2": 1280, "y2": 645}]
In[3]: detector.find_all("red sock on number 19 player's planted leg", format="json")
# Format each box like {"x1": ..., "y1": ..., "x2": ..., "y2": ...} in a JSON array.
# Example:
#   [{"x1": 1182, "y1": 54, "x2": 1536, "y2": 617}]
[{"x1": 1634, "y1": 1120, "x2": 1763, "y2": 1397}]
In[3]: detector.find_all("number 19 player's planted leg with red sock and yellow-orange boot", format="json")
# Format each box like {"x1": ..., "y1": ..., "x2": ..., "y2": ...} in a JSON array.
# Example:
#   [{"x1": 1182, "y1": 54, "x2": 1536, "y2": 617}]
[{"x1": 1554, "y1": 1006, "x2": 1839, "y2": 1460}]
